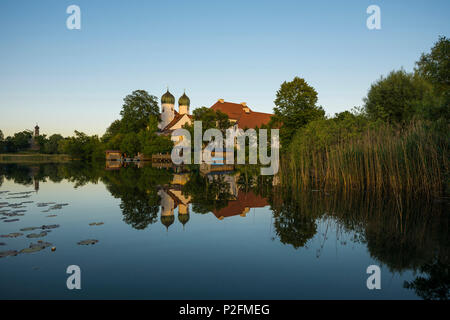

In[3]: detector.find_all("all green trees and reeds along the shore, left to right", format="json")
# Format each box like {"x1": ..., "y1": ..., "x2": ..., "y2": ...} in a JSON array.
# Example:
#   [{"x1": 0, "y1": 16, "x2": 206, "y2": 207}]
[{"x1": 0, "y1": 37, "x2": 450, "y2": 198}]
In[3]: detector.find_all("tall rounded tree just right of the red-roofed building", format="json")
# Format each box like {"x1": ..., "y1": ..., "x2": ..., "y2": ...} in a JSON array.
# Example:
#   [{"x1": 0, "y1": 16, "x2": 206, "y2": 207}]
[{"x1": 272, "y1": 77, "x2": 325, "y2": 146}]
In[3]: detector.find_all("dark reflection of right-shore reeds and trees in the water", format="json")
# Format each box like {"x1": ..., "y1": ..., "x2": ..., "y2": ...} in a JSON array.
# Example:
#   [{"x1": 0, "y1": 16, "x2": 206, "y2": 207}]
[{"x1": 269, "y1": 188, "x2": 449, "y2": 280}]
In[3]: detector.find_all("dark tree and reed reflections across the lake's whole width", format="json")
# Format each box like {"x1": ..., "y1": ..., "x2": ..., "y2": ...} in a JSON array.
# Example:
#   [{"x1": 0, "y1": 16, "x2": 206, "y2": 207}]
[{"x1": 0, "y1": 162, "x2": 449, "y2": 299}]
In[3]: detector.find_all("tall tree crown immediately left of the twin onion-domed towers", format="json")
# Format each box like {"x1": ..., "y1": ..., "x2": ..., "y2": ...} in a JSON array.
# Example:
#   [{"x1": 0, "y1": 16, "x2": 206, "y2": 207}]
[{"x1": 119, "y1": 90, "x2": 159, "y2": 133}]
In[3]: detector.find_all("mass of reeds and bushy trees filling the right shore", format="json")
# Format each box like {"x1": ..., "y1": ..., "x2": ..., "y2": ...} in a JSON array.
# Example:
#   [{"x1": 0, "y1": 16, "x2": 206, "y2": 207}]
[{"x1": 281, "y1": 38, "x2": 450, "y2": 197}]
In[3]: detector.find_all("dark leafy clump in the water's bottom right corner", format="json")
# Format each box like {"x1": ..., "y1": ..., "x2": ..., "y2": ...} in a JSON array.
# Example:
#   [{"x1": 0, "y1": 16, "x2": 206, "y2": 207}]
[{"x1": 404, "y1": 256, "x2": 450, "y2": 300}]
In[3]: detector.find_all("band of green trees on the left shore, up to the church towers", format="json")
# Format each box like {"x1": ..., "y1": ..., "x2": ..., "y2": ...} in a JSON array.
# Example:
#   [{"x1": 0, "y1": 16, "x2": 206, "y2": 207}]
[{"x1": 0, "y1": 90, "x2": 173, "y2": 161}]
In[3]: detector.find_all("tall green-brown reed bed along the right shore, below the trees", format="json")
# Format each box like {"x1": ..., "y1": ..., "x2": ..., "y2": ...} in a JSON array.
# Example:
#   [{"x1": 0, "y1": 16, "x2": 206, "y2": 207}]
[{"x1": 281, "y1": 122, "x2": 449, "y2": 197}]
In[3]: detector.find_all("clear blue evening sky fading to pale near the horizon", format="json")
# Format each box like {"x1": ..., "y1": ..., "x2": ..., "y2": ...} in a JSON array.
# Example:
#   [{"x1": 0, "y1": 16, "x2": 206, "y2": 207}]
[{"x1": 0, "y1": 0, "x2": 450, "y2": 135}]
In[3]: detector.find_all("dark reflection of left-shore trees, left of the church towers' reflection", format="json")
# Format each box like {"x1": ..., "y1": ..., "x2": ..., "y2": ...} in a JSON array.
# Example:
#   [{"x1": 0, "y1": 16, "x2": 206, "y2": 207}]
[{"x1": 0, "y1": 161, "x2": 171, "y2": 229}]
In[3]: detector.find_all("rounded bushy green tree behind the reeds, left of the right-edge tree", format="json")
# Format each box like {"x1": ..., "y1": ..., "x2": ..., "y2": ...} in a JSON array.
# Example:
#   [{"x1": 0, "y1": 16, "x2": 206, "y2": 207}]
[{"x1": 364, "y1": 70, "x2": 431, "y2": 123}]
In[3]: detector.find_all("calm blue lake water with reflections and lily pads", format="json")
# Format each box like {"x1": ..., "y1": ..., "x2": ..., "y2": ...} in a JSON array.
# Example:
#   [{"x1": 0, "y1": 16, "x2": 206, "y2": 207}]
[{"x1": 0, "y1": 163, "x2": 449, "y2": 299}]
